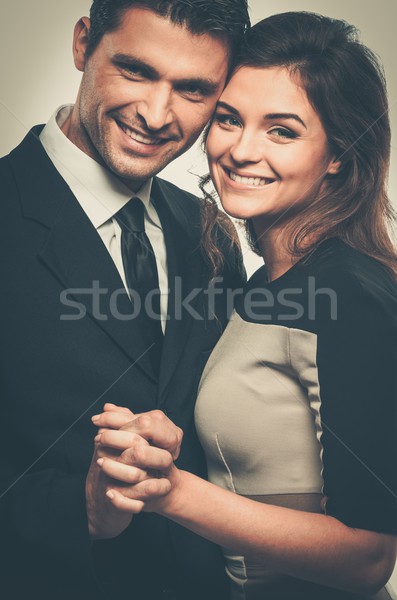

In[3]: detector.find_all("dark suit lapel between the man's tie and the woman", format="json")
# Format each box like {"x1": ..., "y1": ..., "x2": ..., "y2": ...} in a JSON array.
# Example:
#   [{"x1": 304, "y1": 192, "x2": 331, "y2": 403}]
[{"x1": 152, "y1": 178, "x2": 203, "y2": 399}]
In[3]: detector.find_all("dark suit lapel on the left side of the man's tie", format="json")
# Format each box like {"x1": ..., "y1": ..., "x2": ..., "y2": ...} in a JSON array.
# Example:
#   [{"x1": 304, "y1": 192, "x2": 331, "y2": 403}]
[{"x1": 10, "y1": 129, "x2": 156, "y2": 380}]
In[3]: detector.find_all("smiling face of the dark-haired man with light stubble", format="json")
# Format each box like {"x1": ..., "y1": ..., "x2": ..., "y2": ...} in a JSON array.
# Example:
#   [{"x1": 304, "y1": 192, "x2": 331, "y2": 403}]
[{"x1": 67, "y1": 8, "x2": 229, "y2": 190}]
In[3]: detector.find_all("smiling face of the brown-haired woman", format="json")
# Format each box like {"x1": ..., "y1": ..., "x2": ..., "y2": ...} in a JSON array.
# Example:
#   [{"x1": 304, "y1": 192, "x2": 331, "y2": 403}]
[{"x1": 207, "y1": 67, "x2": 339, "y2": 224}]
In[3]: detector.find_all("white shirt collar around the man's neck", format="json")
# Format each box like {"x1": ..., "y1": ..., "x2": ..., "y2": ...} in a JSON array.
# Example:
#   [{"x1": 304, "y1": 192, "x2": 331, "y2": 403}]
[{"x1": 40, "y1": 104, "x2": 153, "y2": 228}]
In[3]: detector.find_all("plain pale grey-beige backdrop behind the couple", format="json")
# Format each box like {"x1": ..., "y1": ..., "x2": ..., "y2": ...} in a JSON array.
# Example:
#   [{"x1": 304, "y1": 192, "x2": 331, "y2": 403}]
[{"x1": 0, "y1": 0, "x2": 397, "y2": 589}]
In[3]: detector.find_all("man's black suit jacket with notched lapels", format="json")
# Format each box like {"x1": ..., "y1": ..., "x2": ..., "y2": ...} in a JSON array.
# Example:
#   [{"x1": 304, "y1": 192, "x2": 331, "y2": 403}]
[{"x1": 0, "y1": 127, "x2": 244, "y2": 600}]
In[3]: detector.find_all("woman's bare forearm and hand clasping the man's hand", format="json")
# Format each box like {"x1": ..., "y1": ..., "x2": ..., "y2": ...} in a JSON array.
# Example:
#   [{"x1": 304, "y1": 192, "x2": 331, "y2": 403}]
[{"x1": 89, "y1": 404, "x2": 397, "y2": 595}]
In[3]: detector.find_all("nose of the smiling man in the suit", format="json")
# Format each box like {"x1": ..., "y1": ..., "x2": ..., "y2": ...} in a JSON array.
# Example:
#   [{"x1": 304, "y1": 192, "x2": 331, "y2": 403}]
[{"x1": 137, "y1": 84, "x2": 174, "y2": 131}]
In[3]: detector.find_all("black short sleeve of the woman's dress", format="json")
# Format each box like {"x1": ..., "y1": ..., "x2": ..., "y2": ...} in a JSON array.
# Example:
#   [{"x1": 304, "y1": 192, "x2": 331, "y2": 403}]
[{"x1": 316, "y1": 273, "x2": 397, "y2": 534}]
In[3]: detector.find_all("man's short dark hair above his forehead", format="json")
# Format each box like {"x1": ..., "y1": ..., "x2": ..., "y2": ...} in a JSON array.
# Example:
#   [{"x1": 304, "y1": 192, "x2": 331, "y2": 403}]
[{"x1": 87, "y1": 0, "x2": 250, "y2": 63}]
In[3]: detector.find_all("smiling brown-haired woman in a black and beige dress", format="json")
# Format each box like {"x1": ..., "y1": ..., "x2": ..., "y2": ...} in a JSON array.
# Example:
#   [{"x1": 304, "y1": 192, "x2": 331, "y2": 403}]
[{"x1": 92, "y1": 13, "x2": 397, "y2": 600}]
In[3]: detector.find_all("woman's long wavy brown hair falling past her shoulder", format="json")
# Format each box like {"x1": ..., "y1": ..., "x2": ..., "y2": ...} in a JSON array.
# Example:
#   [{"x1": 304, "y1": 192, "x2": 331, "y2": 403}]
[{"x1": 201, "y1": 12, "x2": 397, "y2": 279}]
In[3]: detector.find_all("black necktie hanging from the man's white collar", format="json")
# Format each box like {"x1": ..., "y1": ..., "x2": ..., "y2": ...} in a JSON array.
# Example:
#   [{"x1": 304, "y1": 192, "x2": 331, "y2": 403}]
[{"x1": 115, "y1": 198, "x2": 163, "y2": 373}]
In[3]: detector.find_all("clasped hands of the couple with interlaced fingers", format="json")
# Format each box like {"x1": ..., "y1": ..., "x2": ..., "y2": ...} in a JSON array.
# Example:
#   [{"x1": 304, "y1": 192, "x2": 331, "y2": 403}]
[{"x1": 86, "y1": 404, "x2": 183, "y2": 539}]
